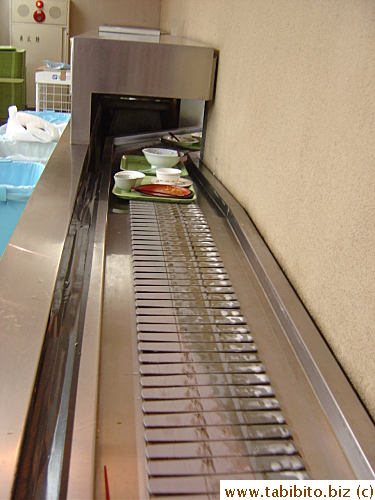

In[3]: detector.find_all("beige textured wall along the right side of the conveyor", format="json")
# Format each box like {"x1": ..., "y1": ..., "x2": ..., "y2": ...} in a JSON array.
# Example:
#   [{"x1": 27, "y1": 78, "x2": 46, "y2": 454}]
[{"x1": 161, "y1": 0, "x2": 375, "y2": 417}]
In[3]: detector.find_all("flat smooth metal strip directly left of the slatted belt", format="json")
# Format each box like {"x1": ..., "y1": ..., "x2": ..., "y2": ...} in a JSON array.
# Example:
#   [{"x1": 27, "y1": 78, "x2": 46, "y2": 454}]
[{"x1": 95, "y1": 208, "x2": 148, "y2": 499}]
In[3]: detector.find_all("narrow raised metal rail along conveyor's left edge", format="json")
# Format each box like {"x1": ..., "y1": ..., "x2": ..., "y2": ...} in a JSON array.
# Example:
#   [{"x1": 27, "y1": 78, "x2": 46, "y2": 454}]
[{"x1": 67, "y1": 141, "x2": 111, "y2": 498}]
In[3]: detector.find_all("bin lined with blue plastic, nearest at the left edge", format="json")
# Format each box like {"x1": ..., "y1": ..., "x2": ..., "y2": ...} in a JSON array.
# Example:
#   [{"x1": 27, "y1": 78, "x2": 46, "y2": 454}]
[{"x1": 0, "y1": 162, "x2": 44, "y2": 258}]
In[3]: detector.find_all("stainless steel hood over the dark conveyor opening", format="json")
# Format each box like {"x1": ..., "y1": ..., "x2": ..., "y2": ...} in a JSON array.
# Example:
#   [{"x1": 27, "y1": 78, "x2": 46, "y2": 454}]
[{"x1": 71, "y1": 31, "x2": 217, "y2": 144}]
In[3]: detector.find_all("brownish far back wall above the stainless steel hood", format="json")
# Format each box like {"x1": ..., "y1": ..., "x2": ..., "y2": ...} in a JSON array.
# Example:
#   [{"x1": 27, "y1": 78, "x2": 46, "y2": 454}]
[{"x1": 70, "y1": 0, "x2": 161, "y2": 36}]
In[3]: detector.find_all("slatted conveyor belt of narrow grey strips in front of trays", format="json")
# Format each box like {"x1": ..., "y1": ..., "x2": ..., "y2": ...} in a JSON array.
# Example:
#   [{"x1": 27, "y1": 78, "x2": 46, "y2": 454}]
[{"x1": 130, "y1": 201, "x2": 309, "y2": 496}]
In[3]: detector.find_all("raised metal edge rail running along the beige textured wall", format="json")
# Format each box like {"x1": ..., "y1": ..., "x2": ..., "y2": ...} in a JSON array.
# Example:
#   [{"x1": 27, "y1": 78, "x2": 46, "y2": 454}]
[{"x1": 191, "y1": 155, "x2": 375, "y2": 479}]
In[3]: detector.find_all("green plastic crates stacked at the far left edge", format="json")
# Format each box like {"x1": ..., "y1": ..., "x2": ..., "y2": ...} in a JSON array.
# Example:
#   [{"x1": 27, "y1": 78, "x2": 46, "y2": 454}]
[{"x1": 0, "y1": 46, "x2": 26, "y2": 121}]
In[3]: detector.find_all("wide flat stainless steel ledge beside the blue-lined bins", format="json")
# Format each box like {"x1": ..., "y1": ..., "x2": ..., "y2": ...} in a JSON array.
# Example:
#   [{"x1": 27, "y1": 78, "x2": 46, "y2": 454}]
[{"x1": 0, "y1": 125, "x2": 87, "y2": 498}]
